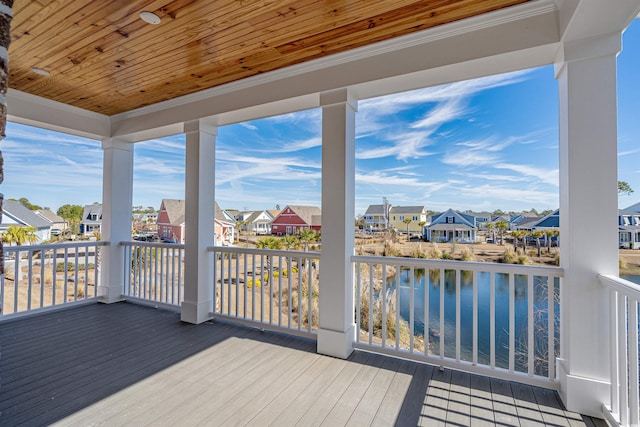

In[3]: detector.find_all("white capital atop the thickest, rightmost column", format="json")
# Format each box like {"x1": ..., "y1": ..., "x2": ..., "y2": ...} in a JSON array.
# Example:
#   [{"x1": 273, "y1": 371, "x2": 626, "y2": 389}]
[{"x1": 554, "y1": 32, "x2": 622, "y2": 78}]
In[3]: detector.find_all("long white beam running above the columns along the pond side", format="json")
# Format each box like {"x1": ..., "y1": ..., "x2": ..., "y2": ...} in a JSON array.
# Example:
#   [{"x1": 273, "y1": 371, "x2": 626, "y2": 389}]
[{"x1": 112, "y1": 0, "x2": 560, "y2": 137}]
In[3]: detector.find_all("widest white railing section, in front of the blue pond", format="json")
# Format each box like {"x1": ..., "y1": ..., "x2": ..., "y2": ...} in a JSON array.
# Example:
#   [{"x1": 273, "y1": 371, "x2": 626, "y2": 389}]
[{"x1": 352, "y1": 256, "x2": 563, "y2": 389}]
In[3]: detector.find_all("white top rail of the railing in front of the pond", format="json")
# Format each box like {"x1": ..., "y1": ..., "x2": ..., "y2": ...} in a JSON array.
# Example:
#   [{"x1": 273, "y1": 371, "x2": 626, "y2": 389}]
[{"x1": 351, "y1": 255, "x2": 564, "y2": 277}]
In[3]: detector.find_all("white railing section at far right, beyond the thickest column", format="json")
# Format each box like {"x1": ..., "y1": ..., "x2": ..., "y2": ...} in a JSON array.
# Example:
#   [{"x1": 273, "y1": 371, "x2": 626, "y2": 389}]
[{"x1": 599, "y1": 275, "x2": 640, "y2": 426}]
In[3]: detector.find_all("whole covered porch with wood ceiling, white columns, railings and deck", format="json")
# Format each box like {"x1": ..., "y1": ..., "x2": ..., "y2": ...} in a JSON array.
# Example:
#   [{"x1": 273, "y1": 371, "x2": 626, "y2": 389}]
[{"x1": 5, "y1": 0, "x2": 640, "y2": 425}]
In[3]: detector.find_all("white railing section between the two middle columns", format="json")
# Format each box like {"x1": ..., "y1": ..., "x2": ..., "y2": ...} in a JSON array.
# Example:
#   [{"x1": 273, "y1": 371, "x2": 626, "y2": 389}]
[{"x1": 209, "y1": 246, "x2": 320, "y2": 337}]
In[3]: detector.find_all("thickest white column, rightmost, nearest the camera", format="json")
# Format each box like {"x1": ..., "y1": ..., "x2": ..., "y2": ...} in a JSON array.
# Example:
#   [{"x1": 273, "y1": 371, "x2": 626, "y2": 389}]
[{"x1": 556, "y1": 34, "x2": 621, "y2": 416}]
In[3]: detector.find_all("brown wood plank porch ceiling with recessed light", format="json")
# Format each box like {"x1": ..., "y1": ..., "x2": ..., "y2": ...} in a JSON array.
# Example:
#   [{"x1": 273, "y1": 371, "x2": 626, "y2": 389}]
[{"x1": 9, "y1": 0, "x2": 529, "y2": 115}]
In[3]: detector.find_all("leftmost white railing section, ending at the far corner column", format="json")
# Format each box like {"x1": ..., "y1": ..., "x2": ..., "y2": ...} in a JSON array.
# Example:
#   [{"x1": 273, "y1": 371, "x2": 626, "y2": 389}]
[{"x1": 0, "y1": 242, "x2": 107, "y2": 317}]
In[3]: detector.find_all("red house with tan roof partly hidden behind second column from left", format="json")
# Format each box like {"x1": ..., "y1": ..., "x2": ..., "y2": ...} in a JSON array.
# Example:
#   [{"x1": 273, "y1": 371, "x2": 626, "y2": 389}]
[{"x1": 157, "y1": 199, "x2": 235, "y2": 246}]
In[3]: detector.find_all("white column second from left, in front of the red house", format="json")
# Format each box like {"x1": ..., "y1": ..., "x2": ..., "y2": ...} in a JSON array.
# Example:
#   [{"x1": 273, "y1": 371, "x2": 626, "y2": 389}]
[{"x1": 181, "y1": 120, "x2": 218, "y2": 324}]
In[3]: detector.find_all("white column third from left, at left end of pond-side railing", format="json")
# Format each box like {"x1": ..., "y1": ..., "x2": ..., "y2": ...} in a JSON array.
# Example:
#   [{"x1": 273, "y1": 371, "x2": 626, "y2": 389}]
[{"x1": 318, "y1": 90, "x2": 357, "y2": 358}]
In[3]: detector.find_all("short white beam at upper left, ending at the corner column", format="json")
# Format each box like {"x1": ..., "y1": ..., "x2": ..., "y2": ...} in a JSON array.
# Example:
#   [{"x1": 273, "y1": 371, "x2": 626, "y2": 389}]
[{"x1": 7, "y1": 89, "x2": 111, "y2": 140}]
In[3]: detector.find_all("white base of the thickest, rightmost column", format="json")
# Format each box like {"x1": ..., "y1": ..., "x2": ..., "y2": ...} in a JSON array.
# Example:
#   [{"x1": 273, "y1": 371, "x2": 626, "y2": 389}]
[{"x1": 556, "y1": 359, "x2": 611, "y2": 418}]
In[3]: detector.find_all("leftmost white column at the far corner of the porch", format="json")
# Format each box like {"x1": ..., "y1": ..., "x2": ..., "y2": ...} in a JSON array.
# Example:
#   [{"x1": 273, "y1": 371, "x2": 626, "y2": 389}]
[{"x1": 98, "y1": 138, "x2": 133, "y2": 303}]
